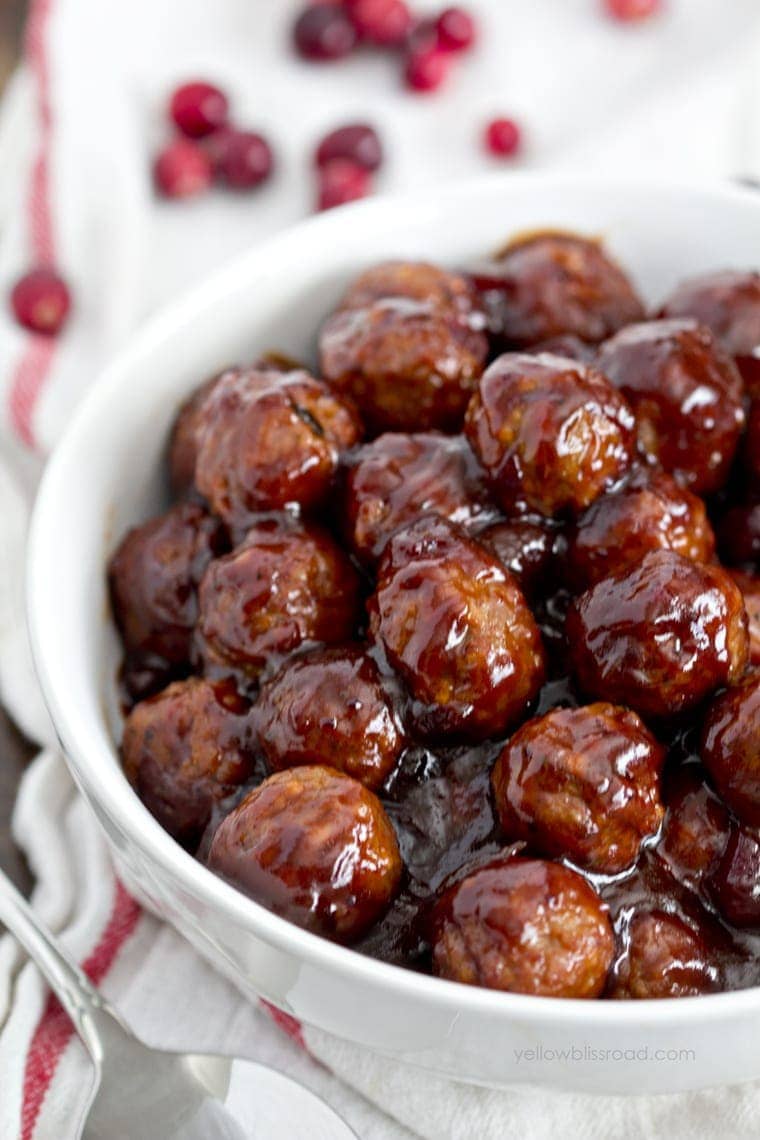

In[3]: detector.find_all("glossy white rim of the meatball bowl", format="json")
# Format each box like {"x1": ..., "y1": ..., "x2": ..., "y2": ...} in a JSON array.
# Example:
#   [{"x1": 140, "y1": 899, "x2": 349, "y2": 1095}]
[{"x1": 26, "y1": 171, "x2": 760, "y2": 1031}]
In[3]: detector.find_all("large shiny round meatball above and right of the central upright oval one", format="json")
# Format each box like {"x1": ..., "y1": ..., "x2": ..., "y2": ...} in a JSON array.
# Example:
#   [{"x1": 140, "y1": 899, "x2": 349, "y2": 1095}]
[{"x1": 465, "y1": 353, "x2": 635, "y2": 516}]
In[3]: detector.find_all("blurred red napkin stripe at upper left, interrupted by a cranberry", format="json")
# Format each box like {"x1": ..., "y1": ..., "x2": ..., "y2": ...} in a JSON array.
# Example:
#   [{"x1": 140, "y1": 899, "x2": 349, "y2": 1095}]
[{"x1": 8, "y1": 0, "x2": 56, "y2": 447}]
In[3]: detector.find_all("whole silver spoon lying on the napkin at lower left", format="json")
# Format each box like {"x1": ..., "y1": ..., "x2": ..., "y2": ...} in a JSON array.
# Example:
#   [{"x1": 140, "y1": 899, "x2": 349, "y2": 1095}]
[{"x1": 0, "y1": 871, "x2": 356, "y2": 1140}]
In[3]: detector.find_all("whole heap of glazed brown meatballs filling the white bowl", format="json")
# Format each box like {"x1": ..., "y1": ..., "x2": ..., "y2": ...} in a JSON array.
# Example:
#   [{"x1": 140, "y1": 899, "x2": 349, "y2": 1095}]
[{"x1": 108, "y1": 231, "x2": 760, "y2": 999}]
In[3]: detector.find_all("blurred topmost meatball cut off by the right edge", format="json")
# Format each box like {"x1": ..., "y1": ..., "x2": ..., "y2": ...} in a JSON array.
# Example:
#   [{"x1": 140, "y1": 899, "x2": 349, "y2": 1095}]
[{"x1": 661, "y1": 270, "x2": 760, "y2": 357}]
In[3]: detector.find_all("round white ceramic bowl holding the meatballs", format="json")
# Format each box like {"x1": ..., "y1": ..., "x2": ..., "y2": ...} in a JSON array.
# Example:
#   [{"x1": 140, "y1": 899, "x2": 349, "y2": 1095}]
[{"x1": 28, "y1": 174, "x2": 760, "y2": 1093}]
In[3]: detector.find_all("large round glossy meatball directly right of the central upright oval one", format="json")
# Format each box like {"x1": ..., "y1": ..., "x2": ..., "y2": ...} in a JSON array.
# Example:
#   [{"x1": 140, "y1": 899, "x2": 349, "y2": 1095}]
[{"x1": 565, "y1": 551, "x2": 749, "y2": 717}]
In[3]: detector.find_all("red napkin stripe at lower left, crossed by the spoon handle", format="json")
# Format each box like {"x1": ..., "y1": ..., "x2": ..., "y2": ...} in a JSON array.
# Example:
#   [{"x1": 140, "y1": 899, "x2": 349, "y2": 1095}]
[{"x1": 21, "y1": 879, "x2": 140, "y2": 1140}]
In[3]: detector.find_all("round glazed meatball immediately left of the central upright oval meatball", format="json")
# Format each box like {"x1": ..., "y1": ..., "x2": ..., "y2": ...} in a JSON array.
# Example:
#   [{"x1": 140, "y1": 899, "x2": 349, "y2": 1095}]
[{"x1": 196, "y1": 515, "x2": 359, "y2": 679}]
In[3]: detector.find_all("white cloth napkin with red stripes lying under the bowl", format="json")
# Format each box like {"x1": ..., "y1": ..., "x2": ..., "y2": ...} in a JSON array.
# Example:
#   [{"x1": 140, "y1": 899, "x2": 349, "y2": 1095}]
[{"x1": 0, "y1": 0, "x2": 760, "y2": 1140}]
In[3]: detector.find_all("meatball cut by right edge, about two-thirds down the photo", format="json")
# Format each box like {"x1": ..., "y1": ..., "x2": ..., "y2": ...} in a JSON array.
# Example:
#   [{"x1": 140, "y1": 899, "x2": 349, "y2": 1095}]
[{"x1": 701, "y1": 671, "x2": 760, "y2": 828}]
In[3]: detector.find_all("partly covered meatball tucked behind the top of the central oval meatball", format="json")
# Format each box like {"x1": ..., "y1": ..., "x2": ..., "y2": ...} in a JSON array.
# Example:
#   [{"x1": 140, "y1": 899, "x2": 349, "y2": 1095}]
[{"x1": 346, "y1": 432, "x2": 495, "y2": 563}]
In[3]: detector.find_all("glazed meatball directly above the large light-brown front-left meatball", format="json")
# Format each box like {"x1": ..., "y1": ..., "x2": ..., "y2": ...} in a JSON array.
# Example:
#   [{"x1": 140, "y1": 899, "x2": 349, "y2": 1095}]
[{"x1": 254, "y1": 646, "x2": 404, "y2": 789}]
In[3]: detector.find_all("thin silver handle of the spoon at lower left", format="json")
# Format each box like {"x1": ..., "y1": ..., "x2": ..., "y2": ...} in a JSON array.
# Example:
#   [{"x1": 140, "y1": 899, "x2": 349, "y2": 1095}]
[{"x1": 0, "y1": 870, "x2": 113, "y2": 1064}]
